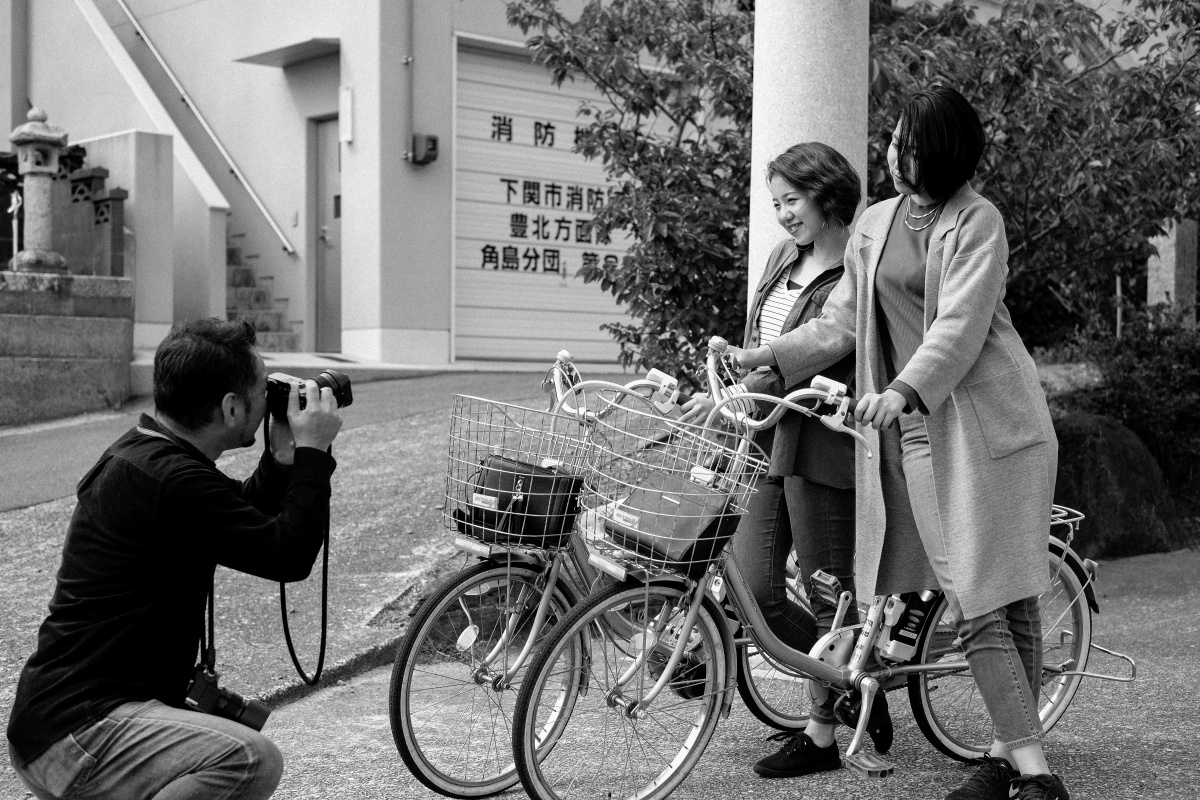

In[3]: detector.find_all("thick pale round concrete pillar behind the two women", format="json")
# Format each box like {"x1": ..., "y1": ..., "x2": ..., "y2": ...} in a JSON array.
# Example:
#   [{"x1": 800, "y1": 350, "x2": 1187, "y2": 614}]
[{"x1": 748, "y1": 0, "x2": 869, "y2": 302}]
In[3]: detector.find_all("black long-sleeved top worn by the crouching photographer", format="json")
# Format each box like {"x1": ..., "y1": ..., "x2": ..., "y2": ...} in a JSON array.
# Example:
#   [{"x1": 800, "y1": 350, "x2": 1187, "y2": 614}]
[{"x1": 8, "y1": 414, "x2": 335, "y2": 762}]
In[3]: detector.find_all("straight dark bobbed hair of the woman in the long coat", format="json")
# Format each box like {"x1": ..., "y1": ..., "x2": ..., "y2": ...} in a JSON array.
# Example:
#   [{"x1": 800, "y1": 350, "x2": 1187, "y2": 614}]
[{"x1": 896, "y1": 86, "x2": 984, "y2": 200}]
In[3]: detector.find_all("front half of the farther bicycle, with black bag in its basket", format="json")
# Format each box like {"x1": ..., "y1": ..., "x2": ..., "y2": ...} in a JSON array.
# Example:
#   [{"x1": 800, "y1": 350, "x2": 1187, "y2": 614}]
[{"x1": 389, "y1": 350, "x2": 734, "y2": 798}]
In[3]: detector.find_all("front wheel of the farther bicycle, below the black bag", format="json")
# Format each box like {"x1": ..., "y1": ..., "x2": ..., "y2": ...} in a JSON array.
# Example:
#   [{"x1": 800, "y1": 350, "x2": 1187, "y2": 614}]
[{"x1": 388, "y1": 561, "x2": 575, "y2": 798}]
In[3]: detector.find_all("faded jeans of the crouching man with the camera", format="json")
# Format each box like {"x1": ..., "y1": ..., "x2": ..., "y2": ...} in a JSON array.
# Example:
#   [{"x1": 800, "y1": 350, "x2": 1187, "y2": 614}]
[{"x1": 8, "y1": 700, "x2": 283, "y2": 800}]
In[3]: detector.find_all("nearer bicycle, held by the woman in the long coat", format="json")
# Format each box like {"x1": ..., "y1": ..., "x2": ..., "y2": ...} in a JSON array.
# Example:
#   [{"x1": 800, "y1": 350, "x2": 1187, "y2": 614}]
[{"x1": 512, "y1": 337, "x2": 1136, "y2": 800}]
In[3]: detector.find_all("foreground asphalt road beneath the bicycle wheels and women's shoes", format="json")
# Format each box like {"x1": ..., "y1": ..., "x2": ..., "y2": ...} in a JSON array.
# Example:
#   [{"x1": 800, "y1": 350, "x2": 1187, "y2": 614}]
[{"x1": 268, "y1": 551, "x2": 1200, "y2": 800}]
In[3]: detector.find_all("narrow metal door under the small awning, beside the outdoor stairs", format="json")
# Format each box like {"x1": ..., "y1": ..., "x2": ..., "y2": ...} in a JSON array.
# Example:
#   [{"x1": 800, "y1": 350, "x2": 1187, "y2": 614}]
[{"x1": 314, "y1": 119, "x2": 342, "y2": 353}]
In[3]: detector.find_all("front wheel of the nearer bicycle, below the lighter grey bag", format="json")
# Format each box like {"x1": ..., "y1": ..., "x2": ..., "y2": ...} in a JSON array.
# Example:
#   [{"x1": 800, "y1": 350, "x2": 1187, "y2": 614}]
[{"x1": 512, "y1": 584, "x2": 727, "y2": 800}]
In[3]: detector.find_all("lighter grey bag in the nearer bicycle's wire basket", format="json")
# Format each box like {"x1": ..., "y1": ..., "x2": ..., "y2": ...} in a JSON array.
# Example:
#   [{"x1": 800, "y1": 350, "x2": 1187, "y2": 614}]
[{"x1": 605, "y1": 470, "x2": 738, "y2": 570}]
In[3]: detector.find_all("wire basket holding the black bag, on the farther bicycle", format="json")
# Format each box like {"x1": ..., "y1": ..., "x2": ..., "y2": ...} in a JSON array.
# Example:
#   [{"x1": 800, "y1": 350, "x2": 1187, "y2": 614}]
[{"x1": 443, "y1": 395, "x2": 589, "y2": 549}]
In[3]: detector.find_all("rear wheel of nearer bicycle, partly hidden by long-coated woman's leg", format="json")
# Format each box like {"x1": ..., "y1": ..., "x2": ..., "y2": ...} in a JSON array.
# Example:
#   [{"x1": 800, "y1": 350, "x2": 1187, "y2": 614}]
[{"x1": 908, "y1": 552, "x2": 1092, "y2": 760}]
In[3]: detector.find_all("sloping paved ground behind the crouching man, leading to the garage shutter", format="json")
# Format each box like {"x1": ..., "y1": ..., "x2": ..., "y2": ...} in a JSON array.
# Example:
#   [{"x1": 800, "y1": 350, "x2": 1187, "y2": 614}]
[{"x1": 0, "y1": 372, "x2": 629, "y2": 800}]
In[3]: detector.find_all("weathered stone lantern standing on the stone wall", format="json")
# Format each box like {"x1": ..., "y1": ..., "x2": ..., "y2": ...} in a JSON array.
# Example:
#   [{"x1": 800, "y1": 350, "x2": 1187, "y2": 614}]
[{"x1": 8, "y1": 108, "x2": 67, "y2": 272}]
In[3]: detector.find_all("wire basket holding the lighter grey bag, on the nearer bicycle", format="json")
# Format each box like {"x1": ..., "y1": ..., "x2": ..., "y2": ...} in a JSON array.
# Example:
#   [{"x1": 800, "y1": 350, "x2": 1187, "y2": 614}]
[{"x1": 581, "y1": 398, "x2": 767, "y2": 577}]
